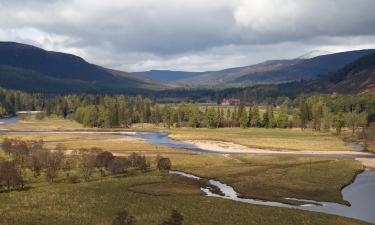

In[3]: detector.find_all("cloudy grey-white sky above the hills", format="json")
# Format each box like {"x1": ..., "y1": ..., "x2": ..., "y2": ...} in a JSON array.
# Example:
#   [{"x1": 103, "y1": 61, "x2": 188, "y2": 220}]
[{"x1": 0, "y1": 0, "x2": 375, "y2": 72}]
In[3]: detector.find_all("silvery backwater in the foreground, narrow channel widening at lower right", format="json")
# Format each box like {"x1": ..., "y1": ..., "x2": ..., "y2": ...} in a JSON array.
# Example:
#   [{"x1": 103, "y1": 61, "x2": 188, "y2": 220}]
[{"x1": 170, "y1": 170, "x2": 375, "y2": 223}]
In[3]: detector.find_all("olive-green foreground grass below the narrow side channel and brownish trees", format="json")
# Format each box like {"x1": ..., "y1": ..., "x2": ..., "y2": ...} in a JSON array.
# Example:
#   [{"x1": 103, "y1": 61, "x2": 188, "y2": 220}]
[{"x1": 0, "y1": 172, "x2": 366, "y2": 225}]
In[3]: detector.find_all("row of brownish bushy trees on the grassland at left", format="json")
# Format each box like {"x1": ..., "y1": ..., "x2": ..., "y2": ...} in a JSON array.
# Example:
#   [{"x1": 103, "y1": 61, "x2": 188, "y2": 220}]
[{"x1": 0, "y1": 138, "x2": 171, "y2": 191}]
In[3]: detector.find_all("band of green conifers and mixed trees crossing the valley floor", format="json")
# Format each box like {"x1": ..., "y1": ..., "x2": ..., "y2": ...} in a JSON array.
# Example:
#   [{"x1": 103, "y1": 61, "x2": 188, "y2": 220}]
[{"x1": 0, "y1": 89, "x2": 375, "y2": 132}]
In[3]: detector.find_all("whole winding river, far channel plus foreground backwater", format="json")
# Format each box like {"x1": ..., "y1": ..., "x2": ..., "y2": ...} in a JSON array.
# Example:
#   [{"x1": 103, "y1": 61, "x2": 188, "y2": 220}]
[{"x1": 0, "y1": 117, "x2": 375, "y2": 223}]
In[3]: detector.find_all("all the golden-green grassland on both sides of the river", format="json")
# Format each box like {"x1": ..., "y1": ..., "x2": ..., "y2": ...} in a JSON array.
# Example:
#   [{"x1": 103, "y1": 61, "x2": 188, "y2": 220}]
[{"x1": 0, "y1": 118, "x2": 366, "y2": 225}]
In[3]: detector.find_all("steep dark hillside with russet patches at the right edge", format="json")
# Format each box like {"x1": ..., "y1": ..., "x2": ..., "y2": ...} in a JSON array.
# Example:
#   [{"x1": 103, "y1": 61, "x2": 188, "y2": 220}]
[{"x1": 303, "y1": 53, "x2": 375, "y2": 93}]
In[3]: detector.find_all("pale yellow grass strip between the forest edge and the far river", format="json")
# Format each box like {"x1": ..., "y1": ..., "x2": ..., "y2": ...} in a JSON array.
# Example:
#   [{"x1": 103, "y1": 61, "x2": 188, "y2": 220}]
[{"x1": 1, "y1": 118, "x2": 351, "y2": 151}]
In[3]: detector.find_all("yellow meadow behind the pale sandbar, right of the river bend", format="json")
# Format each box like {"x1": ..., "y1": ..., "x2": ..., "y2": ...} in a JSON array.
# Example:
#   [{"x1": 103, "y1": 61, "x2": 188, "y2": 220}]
[{"x1": 167, "y1": 128, "x2": 351, "y2": 151}]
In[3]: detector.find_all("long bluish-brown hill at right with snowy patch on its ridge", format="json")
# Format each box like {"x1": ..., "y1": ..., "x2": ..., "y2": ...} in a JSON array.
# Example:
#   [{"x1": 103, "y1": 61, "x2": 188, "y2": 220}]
[{"x1": 145, "y1": 49, "x2": 375, "y2": 88}]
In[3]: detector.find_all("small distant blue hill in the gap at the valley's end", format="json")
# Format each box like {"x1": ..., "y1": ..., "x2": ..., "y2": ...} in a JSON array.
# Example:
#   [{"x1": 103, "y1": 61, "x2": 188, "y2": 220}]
[{"x1": 136, "y1": 70, "x2": 205, "y2": 83}]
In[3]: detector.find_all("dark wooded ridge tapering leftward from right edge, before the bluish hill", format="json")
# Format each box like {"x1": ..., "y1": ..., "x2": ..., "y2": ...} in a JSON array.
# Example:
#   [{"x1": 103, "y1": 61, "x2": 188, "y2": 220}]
[{"x1": 222, "y1": 52, "x2": 375, "y2": 101}]
